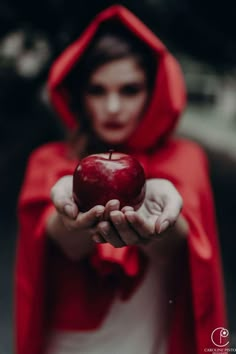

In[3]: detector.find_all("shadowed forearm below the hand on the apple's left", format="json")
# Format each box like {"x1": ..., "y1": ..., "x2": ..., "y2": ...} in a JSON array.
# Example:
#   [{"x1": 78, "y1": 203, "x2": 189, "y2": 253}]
[{"x1": 46, "y1": 211, "x2": 95, "y2": 261}]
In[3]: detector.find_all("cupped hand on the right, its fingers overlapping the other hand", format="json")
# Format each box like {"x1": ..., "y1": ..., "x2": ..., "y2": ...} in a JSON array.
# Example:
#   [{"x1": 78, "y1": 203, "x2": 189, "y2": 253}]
[{"x1": 96, "y1": 179, "x2": 185, "y2": 247}]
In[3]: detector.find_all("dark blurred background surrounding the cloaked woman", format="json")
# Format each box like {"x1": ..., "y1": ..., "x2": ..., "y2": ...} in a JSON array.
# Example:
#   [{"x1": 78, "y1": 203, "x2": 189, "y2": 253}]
[{"x1": 0, "y1": 0, "x2": 236, "y2": 354}]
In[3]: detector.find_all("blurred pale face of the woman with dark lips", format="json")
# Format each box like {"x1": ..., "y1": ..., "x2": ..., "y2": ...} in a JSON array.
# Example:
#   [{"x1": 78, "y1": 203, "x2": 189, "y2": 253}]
[{"x1": 84, "y1": 57, "x2": 148, "y2": 144}]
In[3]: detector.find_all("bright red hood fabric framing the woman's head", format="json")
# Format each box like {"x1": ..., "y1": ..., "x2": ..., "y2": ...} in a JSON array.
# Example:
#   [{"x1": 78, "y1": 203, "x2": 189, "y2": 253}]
[{"x1": 48, "y1": 5, "x2": 186, "y2": 150}]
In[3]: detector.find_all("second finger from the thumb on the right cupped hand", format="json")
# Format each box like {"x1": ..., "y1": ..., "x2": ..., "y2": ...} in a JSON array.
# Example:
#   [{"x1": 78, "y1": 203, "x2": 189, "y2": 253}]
[{"x1": 110, "y1": 210, "x2": 139, "y2": 245}]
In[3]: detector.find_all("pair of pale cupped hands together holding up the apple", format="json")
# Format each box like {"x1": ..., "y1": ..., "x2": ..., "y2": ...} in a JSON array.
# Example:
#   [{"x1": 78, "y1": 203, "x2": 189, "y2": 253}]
[{"x1": 51, "y1": 176, "x2": 183, "y2": 253}]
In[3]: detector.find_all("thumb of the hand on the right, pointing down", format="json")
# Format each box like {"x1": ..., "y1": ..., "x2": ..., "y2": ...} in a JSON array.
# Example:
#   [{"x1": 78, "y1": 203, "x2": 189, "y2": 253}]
[{"x1": 156, "y1": 194, "x2": 183, "y2": 233}]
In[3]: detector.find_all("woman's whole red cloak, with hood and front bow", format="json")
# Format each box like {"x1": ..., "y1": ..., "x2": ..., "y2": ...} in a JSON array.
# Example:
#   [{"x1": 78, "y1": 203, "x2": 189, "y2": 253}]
[{"x1": 15, "y1": 5, "x2": 226, "y2": 354}]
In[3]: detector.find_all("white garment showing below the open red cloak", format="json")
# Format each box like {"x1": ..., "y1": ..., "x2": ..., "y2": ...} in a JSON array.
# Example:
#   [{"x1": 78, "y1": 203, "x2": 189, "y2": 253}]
[{"x1": 46, "y1": 246, "x2": 168, "y2": 354}]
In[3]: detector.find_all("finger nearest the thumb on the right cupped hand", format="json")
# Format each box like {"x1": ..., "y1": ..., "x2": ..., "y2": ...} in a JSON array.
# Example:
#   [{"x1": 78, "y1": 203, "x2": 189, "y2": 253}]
[{"x1": 124, "y1": 211, "x2": 156, "y2": 239}]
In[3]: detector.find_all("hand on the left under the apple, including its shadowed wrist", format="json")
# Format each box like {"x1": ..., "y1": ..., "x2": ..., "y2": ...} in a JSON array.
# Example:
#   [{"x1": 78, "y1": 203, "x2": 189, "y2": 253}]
[{"x1": 47, "y1": 176, "x2": 105, "y2": 260}]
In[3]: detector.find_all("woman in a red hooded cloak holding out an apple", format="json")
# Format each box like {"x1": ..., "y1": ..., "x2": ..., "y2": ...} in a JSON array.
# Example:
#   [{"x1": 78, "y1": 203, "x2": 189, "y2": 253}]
[{"x1": 16, "y1": 6, "x2": 225, "y2": 354}]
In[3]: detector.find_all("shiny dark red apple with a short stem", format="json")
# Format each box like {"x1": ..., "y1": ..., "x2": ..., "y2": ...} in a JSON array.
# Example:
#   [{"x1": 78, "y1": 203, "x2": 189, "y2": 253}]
[{"x1": 73, "y1": 152, "x2": 146, "y2": 212}]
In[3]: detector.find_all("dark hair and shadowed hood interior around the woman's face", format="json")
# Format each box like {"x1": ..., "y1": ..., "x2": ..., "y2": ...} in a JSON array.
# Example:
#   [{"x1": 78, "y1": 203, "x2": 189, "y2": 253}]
[{"x1": 61, "y1": 20, "x2": 158, "y2": 129}]
